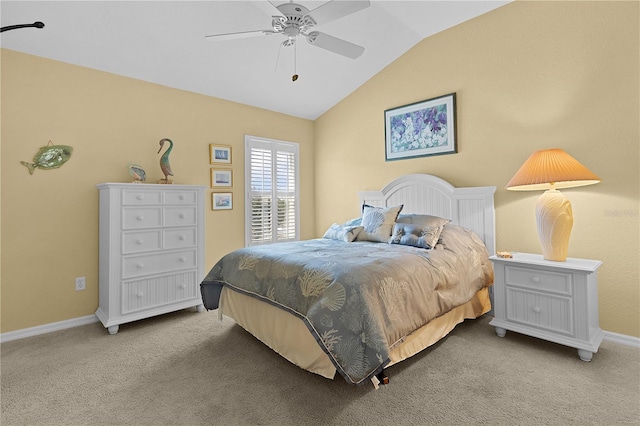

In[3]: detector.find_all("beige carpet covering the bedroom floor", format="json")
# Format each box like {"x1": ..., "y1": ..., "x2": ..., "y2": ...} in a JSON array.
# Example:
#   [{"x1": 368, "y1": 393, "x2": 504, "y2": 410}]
[{"x1": 1, "y1": 310, "x2": 640, "y2": 426}]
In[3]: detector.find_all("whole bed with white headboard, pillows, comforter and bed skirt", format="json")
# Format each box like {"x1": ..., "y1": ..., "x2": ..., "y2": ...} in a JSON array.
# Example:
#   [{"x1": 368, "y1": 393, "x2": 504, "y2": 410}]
[{"x1": 201, "y1": 174, "x2": 495, "y2": 387}]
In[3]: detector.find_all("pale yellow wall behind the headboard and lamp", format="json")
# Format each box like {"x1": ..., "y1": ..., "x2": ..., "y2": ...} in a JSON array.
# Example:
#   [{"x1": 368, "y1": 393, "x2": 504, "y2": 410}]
[{"x1": 315, "y1": 2, "x2": 640, "y2": 337}]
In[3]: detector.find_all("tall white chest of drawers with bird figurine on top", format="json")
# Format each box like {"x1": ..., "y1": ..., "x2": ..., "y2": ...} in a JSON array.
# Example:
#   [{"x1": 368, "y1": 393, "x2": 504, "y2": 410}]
[{"x1": 96, "y1": 183, "x2": 206, "y2": 334}]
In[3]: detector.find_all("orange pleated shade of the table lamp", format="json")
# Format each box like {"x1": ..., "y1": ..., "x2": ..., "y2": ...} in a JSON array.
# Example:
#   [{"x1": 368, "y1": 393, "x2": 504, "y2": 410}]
[{"x1": 506, "y1": 148, "x2": 600, "y2": 191}]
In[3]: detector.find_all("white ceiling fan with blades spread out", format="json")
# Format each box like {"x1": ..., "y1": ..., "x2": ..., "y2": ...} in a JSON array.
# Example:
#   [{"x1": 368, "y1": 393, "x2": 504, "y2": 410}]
[{"x1": 205, "y1": 0, "x2": 370, "y2": 59}]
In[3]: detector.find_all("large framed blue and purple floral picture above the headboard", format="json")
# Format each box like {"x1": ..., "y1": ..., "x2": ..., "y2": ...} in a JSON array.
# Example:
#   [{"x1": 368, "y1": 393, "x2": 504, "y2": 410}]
[{"x1": 384, "y1": 93, "x2": 458, "y2": 161}]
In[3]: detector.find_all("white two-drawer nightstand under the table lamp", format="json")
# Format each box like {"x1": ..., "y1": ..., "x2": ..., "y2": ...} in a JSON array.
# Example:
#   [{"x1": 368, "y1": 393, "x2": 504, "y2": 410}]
[{"x1": 489, "y1": 253, "x2": 604, "y2": 361}]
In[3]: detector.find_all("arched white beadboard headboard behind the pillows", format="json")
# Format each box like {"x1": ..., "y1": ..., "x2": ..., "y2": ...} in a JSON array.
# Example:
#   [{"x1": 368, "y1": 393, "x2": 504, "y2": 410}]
[{"x1": 358, "y1": 174, "x2": 496, "y2": 255}]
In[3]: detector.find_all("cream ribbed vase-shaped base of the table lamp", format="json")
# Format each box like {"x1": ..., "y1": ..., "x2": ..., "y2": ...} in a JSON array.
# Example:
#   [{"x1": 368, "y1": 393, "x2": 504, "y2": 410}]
[{"x1": 536, "y1": 189, "x2": 573, "y2": 262}]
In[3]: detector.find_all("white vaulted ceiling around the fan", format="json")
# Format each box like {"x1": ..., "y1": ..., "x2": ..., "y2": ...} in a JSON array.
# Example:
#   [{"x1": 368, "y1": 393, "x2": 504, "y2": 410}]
[{"x1": 0, "y1": 0, "x2": 508, "y2": 119}]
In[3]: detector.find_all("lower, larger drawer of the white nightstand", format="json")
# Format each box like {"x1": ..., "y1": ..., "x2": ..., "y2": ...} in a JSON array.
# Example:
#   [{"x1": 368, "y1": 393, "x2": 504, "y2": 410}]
[{"x1": 506, "y1": 287, "x2": 574, "y2": 336}]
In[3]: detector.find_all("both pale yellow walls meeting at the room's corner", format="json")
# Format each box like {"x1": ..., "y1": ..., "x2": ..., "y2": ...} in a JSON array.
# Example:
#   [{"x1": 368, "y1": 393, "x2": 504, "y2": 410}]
[{"x1": 0, "y1": 2, "x2": 640, "y2": 337}]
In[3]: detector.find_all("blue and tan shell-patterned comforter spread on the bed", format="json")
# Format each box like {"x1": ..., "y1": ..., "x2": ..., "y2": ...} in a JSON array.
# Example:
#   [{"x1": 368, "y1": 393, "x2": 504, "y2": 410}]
[{"x1": 204, "y1": 225, "x2": 493, "y2": 384}]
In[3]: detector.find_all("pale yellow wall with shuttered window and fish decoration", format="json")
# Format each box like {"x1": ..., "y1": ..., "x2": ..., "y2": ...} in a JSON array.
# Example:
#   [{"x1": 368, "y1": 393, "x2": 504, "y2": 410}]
[{"x1": 1, "y1": 49, "x2": 314, "y2": 332}]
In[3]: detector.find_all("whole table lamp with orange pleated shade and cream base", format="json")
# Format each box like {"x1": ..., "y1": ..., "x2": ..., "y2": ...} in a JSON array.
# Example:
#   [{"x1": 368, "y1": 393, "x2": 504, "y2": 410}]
[{"x1": 506, "y1": 148, "x2": 600, "y2": 262}]
